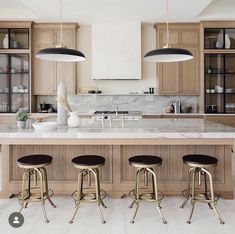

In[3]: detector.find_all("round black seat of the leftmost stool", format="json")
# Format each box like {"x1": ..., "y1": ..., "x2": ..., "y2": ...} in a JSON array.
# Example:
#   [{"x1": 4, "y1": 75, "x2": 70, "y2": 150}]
[{"x1": 17, "y1": 154, "x2": 53, "y2": 166}]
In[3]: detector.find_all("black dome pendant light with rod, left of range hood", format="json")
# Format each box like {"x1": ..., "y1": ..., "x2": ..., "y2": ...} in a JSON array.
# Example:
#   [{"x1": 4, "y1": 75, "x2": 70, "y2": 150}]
[{"x1": 36, "y1": 0, "x2": 86, "y2": 62}]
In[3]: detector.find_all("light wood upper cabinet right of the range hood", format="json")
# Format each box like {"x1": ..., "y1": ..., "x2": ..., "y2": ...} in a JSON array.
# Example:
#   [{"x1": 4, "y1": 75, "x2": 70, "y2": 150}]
[{"x1": 154, "y1": 23, "x2": 200, "y2": 95}]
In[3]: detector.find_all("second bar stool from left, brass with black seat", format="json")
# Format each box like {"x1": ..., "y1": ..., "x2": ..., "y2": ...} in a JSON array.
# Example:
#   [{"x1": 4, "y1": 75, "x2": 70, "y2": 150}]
[{"x1": 69, "y1": 155, "x2": 106, "y2": 223}]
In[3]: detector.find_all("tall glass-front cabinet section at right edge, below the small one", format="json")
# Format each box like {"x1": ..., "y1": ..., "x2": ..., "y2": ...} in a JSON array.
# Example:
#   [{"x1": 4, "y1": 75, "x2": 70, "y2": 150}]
[{"x1": 204, "y1": 53, "x2": 235, "y2": 113}]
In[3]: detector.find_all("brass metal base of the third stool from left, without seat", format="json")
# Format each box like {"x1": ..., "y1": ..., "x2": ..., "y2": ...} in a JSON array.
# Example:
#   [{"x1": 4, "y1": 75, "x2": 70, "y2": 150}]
[{"x1": 129, "y1": 163, "x2": 167, "y2": 224}]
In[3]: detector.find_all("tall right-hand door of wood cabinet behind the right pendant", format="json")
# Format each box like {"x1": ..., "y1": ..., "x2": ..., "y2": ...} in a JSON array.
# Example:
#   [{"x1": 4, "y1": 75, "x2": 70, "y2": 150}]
[{"x1": 180, "y1": 47, "x2": 200, "y2": 95}]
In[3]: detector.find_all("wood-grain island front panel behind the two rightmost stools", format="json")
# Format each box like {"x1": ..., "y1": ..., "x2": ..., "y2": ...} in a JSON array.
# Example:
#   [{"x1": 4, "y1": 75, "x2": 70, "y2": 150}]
[{"x1": 121, "y1": 145, "x2": 229, "y2": 183}]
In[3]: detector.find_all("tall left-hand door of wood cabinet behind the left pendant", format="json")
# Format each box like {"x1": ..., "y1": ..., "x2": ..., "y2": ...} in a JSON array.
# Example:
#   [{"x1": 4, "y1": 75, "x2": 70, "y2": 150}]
[{"x1": 33, "y1": 47, "x2": 55, "y2": 95}]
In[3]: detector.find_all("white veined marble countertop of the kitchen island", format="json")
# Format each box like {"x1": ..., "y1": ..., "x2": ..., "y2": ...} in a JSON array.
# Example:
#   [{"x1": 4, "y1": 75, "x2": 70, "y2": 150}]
[{"x1": 0, "y1": 119, "x2": 235, "y2": 139}]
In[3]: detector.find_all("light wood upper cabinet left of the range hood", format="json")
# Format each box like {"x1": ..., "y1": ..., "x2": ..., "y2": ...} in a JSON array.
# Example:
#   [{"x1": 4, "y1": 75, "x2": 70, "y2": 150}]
[{"x1": 33, "y1": 23, "x2": 77, "y2": 95}]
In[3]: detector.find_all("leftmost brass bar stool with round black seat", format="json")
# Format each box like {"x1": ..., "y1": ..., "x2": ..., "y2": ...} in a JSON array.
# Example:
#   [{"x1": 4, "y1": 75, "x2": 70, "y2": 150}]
[{"x1": 17, "y1": 154, "x2": 56, "y2": 223}]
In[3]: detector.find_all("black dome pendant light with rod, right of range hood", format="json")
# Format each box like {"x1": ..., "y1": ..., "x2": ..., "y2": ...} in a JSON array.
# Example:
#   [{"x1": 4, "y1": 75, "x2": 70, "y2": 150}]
[{"x1": 144, "y1": 0, "x2": 193, "y2": 62}]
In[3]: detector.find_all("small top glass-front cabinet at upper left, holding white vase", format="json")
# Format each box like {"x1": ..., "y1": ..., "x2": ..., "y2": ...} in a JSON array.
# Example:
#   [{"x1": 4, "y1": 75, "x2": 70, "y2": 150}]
[{"x1": 0, "y1": 28, "x2": 29, "y2": 49}]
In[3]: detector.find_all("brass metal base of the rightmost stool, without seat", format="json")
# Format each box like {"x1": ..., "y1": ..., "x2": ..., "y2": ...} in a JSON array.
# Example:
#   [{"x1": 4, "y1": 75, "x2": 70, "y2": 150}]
[{"x1": 180, "y1": 163, "x2": 224, "y2": 224}]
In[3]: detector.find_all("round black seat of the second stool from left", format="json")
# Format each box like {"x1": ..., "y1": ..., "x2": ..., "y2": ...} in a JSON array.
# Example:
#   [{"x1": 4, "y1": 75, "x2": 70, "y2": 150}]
[{"x1": 72, "y1": 155, "x2": 105, "y2": 166}]
